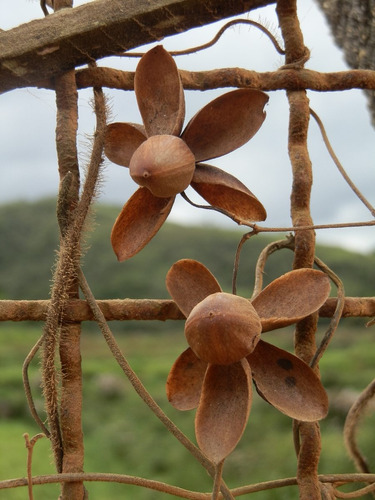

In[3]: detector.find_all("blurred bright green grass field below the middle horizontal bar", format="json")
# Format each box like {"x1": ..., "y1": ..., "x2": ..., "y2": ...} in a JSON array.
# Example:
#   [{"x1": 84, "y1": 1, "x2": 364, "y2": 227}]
[{"x1": 0, "y1": 322, "x2": 375, "y2": 500}]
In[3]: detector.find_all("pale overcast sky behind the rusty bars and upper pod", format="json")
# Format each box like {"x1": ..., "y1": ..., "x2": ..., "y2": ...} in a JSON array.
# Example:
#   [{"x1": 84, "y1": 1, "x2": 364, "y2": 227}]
[{"x1": 0, "y1": 0, "x2": 375, "y2": 252}]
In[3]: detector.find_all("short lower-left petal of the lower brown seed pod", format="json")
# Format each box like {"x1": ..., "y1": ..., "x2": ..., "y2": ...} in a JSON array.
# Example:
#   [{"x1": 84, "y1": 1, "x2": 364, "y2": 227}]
[{"x1": 167, "y1": 347, "x2": 207, "y2": 410}]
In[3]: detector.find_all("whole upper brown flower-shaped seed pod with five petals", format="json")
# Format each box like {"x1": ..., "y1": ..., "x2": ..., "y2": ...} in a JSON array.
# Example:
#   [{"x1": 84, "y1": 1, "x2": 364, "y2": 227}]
[{"x1": 105, "y1": 45, "x2": 268, "y2": 261}]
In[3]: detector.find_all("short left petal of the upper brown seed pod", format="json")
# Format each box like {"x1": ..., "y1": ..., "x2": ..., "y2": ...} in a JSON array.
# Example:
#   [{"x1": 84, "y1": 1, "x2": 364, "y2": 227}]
[{"x1": 104, "y1": 123, "x2": 146, "y2": 167}]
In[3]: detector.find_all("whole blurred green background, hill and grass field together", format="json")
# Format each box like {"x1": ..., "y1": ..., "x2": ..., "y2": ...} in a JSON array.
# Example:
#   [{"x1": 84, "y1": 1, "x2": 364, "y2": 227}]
[{"x1": 0, "y1": 200, "x2": 375, "y2": 500}]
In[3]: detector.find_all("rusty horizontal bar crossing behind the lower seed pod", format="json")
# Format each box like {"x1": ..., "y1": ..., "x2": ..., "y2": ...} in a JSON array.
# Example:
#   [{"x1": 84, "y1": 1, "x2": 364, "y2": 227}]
[{"x1": 0, "y1": 297, "x2": 375, "y2": 322}]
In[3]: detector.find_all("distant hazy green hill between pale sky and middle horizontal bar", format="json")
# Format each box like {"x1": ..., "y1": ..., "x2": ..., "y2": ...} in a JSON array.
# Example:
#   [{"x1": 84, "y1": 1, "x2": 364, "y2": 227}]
[{"x1": 0, "y1": 199, "x2": 375, "y2": 299}]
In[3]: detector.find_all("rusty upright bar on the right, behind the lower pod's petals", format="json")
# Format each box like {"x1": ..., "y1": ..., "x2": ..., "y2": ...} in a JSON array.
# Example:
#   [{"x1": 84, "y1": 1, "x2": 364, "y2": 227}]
[{"x1": 276, "y1": 0, "x2": 321, "y2": 500}]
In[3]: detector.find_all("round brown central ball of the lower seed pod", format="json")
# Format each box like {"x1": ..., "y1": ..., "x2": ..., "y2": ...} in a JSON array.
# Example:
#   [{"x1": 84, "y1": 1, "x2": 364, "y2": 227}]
[{"x1": 185, "y1": 292, "x2": 262, "y2": 365}]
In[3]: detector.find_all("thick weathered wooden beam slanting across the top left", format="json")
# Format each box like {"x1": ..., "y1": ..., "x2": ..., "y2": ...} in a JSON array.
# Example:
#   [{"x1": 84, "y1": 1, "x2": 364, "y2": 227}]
[{"x1": 0, "y1": 0, "x2": 274, "y2": 93}]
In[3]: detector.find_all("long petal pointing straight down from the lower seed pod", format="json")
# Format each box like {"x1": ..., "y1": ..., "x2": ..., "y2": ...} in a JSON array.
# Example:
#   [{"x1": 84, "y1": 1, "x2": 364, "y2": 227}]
[{"x1": 195, "y1": 359, "x2": 252, "y2": 464}]
